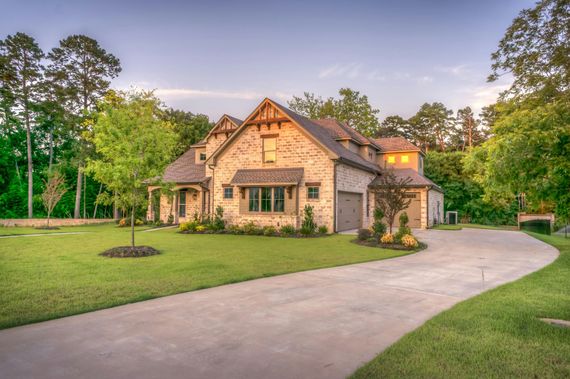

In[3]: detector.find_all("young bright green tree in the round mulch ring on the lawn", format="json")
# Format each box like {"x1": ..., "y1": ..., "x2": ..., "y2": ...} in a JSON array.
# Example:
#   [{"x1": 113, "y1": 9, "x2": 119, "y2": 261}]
[{"x1": 87, "y1": 92, "x2": 176, "y2": 248}]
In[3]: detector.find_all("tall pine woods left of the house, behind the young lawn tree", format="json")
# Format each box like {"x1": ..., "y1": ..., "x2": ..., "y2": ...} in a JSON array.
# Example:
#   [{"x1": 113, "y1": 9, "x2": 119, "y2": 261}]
[{"x1": 0, "y1": 33, "x2": 212, "y2": 218}]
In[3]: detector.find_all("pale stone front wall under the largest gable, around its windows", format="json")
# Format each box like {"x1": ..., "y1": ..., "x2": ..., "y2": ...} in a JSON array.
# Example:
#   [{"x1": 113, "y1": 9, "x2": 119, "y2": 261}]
[{"x1": 212, "y1": 122, "x2": 334, "y2": 231}]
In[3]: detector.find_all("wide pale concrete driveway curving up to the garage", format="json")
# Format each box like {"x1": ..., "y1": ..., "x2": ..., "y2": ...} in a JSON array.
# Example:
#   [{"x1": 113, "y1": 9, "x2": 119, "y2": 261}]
[{"x1": 0, "y1": 229, "x2": 558, "y2": 378}]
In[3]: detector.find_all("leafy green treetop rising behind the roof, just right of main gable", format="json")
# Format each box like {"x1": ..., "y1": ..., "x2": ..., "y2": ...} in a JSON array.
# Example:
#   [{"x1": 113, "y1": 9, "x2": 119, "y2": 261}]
[{"x1": 288, "y1": 88, "x2": 380, "y2": 136}]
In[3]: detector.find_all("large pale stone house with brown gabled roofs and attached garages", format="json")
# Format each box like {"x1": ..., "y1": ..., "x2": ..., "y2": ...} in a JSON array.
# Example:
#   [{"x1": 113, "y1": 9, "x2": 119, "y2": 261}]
[{"x1": 147, "y1": 99, "x2": 443, "y2": 232}]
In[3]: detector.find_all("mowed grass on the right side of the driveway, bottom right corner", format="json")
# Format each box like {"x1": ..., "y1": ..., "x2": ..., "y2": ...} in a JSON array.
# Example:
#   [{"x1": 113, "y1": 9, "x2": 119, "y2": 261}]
[{"x1": 353, "y1": 233, "x2": 570, "y2": 378}]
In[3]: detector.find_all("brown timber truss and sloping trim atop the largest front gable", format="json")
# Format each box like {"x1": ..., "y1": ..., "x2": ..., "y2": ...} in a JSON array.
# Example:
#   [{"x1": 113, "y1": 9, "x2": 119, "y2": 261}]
[{"x1": 206, "y1": 98, "x2": 338, "y2": 163}]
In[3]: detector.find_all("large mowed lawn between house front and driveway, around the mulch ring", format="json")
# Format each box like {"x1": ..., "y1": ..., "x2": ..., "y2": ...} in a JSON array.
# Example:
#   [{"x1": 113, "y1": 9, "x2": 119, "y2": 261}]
[{"x1": 0, "y1": 225, "x2": 407, "y2": 328}]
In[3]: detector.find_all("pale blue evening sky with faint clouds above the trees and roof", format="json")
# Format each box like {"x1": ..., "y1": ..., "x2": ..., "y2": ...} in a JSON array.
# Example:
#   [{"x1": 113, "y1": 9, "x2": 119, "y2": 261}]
[{"x1": 0, "y1": 0, "x2": 534, "y2": 119}]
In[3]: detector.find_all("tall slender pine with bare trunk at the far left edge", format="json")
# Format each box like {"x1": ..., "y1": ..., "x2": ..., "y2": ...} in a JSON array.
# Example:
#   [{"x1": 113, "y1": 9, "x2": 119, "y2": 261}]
[{"x1": 0, "y1": 33, "x2": 44, "y2": 218}]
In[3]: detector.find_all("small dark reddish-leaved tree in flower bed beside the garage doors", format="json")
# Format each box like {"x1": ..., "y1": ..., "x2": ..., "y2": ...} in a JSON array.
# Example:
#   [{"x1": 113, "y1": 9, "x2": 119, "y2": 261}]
[{"x1": 373, "y1": 169, "x2": 412, "y2": 234}]
